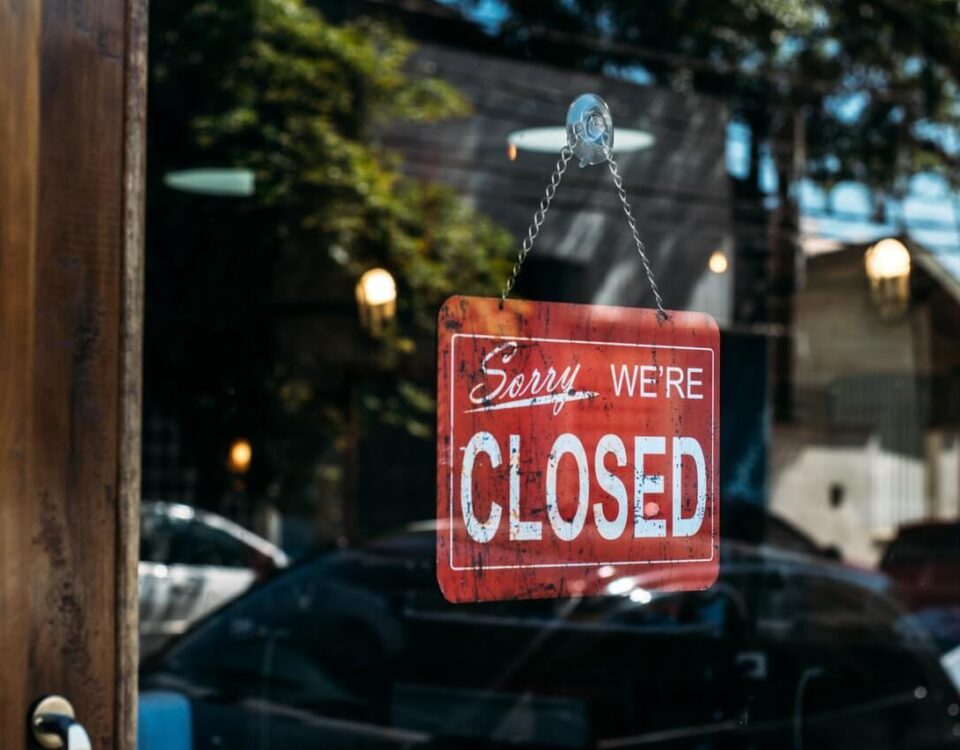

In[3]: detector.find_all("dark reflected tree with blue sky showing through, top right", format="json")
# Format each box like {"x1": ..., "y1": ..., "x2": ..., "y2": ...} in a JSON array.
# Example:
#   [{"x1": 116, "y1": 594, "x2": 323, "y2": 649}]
[{"x1": 462, "y1": 0, "x2": 960, "y2": 197}]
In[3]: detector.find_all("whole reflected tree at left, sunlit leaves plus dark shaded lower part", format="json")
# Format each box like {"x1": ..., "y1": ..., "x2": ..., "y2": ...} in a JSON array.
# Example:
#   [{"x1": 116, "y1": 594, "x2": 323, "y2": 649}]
[{"x1": 146, "y1": 0, "x2": 510, "y2": 516}]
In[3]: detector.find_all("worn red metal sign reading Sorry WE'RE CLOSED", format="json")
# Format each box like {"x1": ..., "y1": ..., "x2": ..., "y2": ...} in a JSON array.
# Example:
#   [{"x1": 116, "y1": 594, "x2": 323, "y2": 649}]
[{"x1": 437, "y1": 297, "x2": 720, "y2": 602}]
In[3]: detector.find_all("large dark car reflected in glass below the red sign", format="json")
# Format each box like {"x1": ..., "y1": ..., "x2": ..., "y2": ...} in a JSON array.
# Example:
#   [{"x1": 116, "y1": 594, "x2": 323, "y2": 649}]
[{"x1": 141, "y1": 529, "x2": 960, "y2": 750}]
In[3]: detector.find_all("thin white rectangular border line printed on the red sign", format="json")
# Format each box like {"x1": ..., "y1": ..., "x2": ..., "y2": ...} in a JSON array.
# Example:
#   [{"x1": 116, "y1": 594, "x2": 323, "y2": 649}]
[{"x1": 447, "y1": 333, "x2": 717, "y2": 570}]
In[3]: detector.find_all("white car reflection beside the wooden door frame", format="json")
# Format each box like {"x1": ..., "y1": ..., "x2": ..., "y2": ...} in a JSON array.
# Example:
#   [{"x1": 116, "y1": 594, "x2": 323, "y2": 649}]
[{"x1": 139, "y1": 502, "x2": 288, "y2": 653}]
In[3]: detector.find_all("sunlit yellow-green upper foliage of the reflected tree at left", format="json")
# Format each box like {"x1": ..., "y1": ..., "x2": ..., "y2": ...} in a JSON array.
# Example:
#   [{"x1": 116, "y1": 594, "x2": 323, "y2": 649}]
[{"x1": 150, "y1": 0, "x2": 510, "y2": 350}]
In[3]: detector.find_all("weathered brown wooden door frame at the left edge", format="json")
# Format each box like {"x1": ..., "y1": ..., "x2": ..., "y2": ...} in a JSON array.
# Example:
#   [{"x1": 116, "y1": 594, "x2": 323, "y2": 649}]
[{"x1": 0, "y1": 0, "x2": 147, "y2": 750}]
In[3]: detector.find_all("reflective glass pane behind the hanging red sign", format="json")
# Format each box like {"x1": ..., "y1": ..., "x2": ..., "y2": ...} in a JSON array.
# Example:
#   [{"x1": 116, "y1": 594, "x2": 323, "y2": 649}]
[{"x1": 140, "y1": 0, "x2": 960, "y2": 750}]
